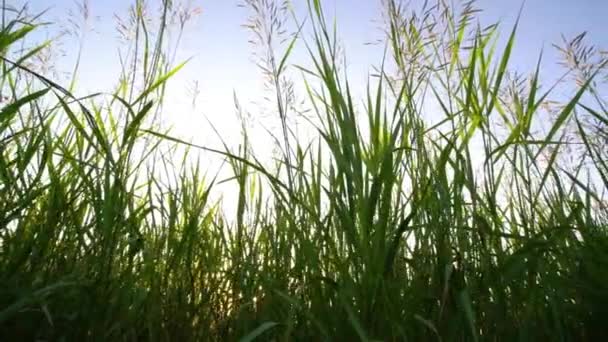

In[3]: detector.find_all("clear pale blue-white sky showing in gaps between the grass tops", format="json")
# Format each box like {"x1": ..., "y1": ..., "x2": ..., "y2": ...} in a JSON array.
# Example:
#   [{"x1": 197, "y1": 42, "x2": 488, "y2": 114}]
[{"x1": 26, "y1": 0, "x2": 608, "y2": 147}]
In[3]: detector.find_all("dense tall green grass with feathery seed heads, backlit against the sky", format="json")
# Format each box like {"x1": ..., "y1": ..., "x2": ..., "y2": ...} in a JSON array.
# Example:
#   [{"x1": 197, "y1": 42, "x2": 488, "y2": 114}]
[{"x1": 0, "y1": 0, "x2": 608, "y2": 341}]
